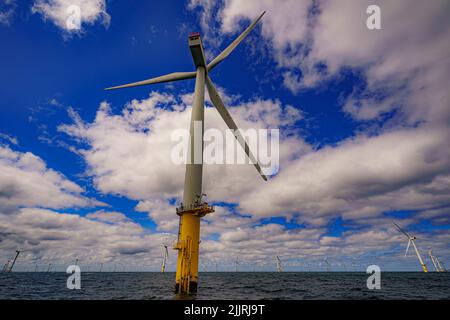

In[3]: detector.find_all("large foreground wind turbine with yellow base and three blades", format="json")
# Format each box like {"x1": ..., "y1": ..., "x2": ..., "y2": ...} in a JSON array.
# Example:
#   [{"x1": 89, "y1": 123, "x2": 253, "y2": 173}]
[{"x1": 105, "y1": 11, "x2": 267, "y2": 294}]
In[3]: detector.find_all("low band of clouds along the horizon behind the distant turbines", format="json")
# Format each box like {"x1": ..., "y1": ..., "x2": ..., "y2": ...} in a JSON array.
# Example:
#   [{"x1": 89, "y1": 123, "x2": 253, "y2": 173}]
[{"x1": 0, "y1": 208, "x2": 449, "y2": 270}]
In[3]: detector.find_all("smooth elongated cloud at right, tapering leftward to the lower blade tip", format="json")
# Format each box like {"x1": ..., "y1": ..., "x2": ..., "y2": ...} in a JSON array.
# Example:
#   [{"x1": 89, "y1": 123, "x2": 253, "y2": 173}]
[{"x1": 240, "y1": 125, "x2": 450, "y2": 224}]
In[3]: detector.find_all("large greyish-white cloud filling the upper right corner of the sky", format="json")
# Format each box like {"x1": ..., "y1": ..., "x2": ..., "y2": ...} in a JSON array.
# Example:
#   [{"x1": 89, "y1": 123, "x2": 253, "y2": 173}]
[{"x1": 196, "y1": 0, "x2": 450, "y2": 128}]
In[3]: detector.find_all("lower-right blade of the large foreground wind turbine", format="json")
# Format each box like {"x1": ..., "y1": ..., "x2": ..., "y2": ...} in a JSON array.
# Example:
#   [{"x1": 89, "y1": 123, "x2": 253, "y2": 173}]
[{"x1": 206, "y1": 76, "x2": 267, "y2": 181}]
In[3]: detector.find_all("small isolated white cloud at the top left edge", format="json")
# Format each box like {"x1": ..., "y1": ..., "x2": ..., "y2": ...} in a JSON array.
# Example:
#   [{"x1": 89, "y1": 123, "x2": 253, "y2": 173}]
[{"x1": 31, "y1": 0, "x2": 111, "y2": 33}]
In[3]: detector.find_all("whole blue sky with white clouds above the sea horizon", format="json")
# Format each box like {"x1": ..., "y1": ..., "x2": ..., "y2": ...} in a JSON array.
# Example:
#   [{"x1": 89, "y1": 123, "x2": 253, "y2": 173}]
[{"x1": 0, "y1": 0, "x2": 450, "y2": 271}]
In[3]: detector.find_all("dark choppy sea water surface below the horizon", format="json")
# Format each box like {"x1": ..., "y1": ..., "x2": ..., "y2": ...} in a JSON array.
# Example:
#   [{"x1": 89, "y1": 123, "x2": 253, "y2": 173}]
[{"x1": 0, "y1": 272, "x2": 450, "y2": 300}]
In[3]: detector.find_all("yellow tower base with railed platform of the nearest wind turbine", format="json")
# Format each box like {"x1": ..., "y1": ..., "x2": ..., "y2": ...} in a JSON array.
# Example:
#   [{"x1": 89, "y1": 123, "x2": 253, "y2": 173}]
[{"x1": 173, "y1": 202, "x2": 214, "y2": 294}]
